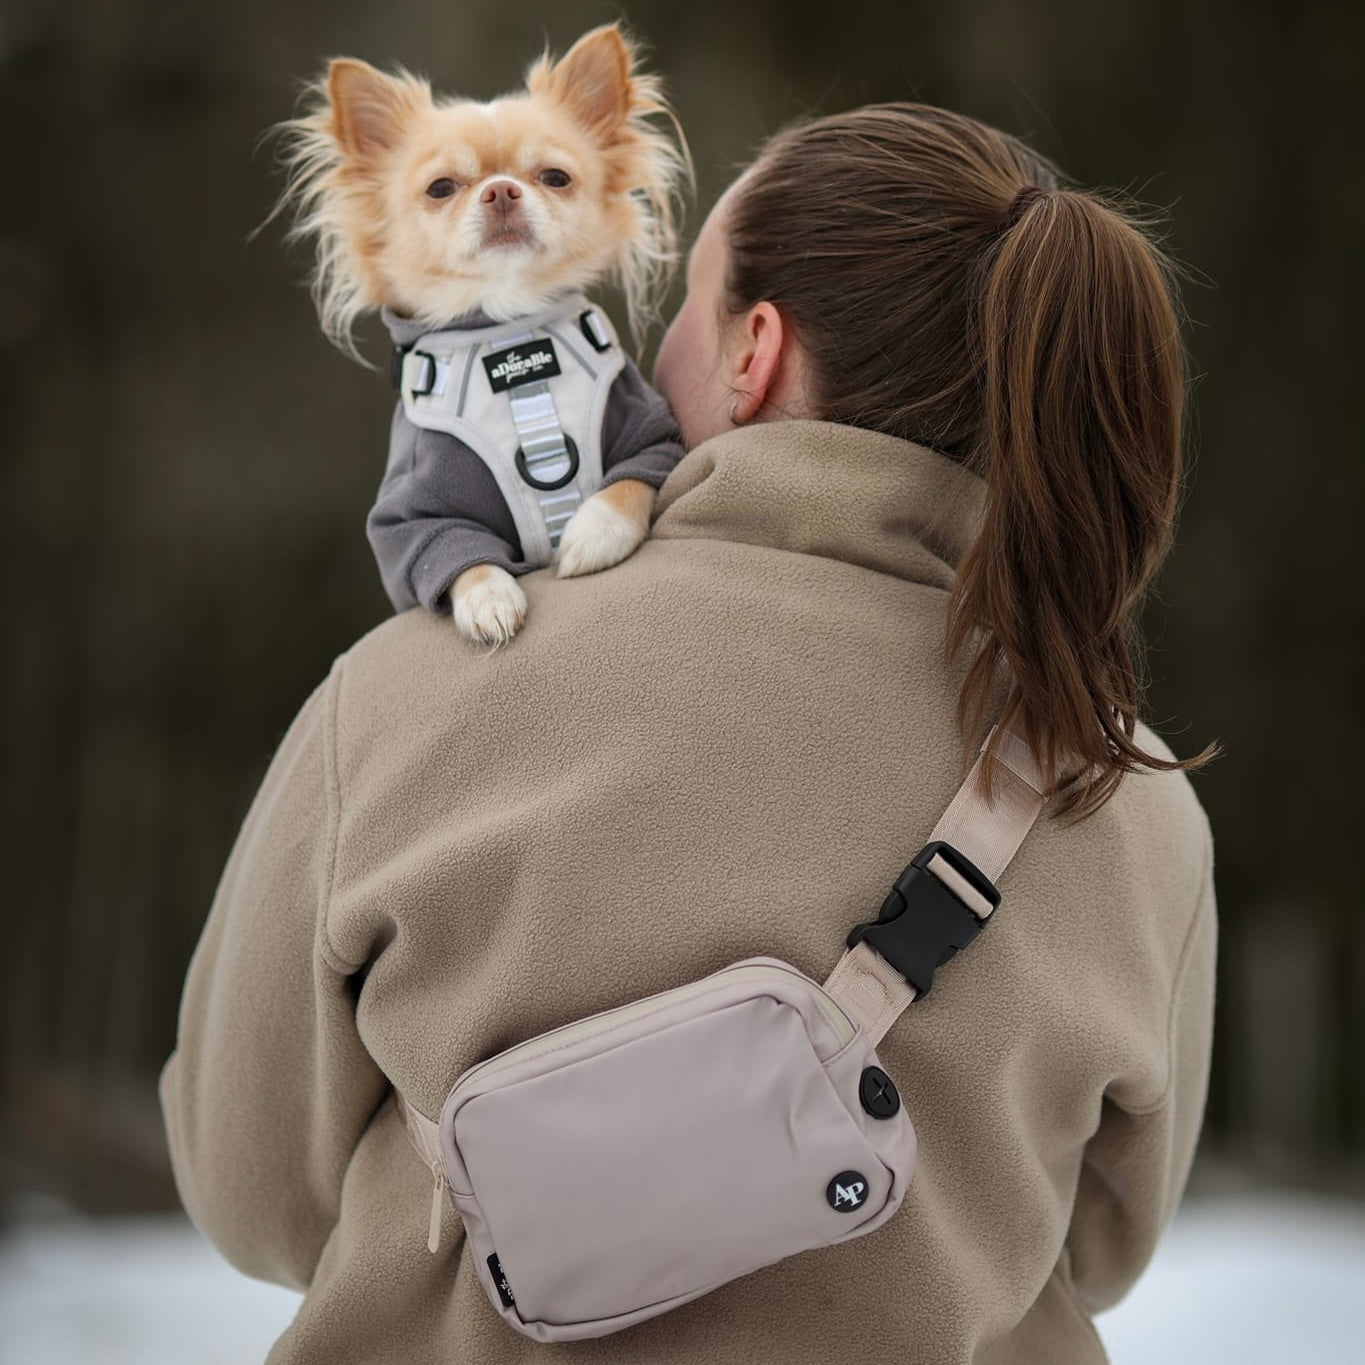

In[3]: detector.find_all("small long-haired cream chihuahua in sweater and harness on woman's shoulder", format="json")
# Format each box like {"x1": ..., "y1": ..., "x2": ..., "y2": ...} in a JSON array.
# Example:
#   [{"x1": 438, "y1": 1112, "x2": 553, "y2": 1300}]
[{"x1": 274, "y1": 23, "x2": 695, "y2": 646}]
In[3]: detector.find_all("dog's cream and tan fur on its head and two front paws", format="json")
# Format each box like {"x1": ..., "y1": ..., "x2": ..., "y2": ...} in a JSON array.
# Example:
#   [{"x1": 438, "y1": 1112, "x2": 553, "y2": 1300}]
[{"x1": 267, "y1": 23, "x2": 693, "y2": 644}]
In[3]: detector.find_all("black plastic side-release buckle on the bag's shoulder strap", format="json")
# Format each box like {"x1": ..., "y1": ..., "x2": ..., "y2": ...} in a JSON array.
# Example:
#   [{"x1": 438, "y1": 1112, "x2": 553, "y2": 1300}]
[{"x1": 848, "y1": 839, "x2": 1001, "y2": 995}]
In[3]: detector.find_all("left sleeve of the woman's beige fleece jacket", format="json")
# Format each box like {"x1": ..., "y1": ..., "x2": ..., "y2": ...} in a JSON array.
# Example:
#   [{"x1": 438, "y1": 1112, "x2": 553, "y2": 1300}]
[{"x1": 160, "y1": 672, "x2": 388, "y2": 1290}]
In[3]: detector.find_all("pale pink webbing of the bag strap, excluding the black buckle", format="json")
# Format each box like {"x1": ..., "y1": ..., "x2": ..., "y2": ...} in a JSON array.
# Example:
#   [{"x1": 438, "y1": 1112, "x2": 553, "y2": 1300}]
[{"x1": 823, "y1": 726, "x2": 1044, "y2": 1047}]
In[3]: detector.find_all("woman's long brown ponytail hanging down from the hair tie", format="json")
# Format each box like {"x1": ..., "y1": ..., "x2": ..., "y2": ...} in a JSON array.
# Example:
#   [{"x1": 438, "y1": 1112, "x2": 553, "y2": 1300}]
[{"x1": 947, "y1": 187, "x2": 1218, "y2": 819}]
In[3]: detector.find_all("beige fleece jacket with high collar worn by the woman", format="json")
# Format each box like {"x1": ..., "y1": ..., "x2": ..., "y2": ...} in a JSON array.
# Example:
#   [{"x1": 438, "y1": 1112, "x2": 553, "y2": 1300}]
[{"x1": 161, "y1": 422, "x2": 1216, "y2": 1365}]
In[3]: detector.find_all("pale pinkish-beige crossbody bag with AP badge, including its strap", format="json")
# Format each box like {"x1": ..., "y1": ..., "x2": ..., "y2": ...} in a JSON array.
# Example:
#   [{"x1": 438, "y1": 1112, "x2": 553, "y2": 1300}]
[{"x1": 394, "y1": 730, "x2": 1043, "y2": 1342}]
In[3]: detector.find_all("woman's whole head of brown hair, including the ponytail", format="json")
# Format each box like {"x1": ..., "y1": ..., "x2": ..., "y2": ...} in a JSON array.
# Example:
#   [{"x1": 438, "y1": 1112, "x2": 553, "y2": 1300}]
[{"x1": 723, "y1": 104, "x2": 1218, "y2": 819}]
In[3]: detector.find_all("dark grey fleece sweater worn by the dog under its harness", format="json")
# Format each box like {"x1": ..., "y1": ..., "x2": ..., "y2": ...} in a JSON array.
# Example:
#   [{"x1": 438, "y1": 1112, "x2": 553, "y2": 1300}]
[{"x1": 366, "y1": 308, "x2": 683, "y2": 612}]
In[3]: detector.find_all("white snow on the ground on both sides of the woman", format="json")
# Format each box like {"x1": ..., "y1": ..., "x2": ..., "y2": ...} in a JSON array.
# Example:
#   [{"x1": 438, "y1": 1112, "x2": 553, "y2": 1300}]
[{"x1": 0, "y1": 1194, "x2": 1365, "y2": 1365}]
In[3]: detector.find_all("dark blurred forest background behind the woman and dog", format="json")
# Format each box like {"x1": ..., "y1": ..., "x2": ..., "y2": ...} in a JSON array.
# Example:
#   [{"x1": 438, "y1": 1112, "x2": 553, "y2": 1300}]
[{"x1": 0, "y1": 0, "x2": 1365, "y2": 1211}]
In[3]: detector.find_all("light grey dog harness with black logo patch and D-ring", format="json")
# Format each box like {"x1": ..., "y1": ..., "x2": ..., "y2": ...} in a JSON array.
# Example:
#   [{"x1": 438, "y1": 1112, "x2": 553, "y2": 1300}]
[{"x1": 396, "y1": 293, "x2": 625, "y2": 565}]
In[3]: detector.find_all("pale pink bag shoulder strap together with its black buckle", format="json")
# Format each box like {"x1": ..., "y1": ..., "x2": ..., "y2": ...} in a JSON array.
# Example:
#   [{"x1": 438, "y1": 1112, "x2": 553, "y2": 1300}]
[{"x1": 823, "y1": 725, "x2": 1044, "y2": 1047}]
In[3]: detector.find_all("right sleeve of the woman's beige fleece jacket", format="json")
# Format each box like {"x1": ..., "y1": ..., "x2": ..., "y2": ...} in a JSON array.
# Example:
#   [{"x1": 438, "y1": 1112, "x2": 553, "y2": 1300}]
[{"x1": 1066, "y1": 842, "x2": 1218, "y2": 1313}]
